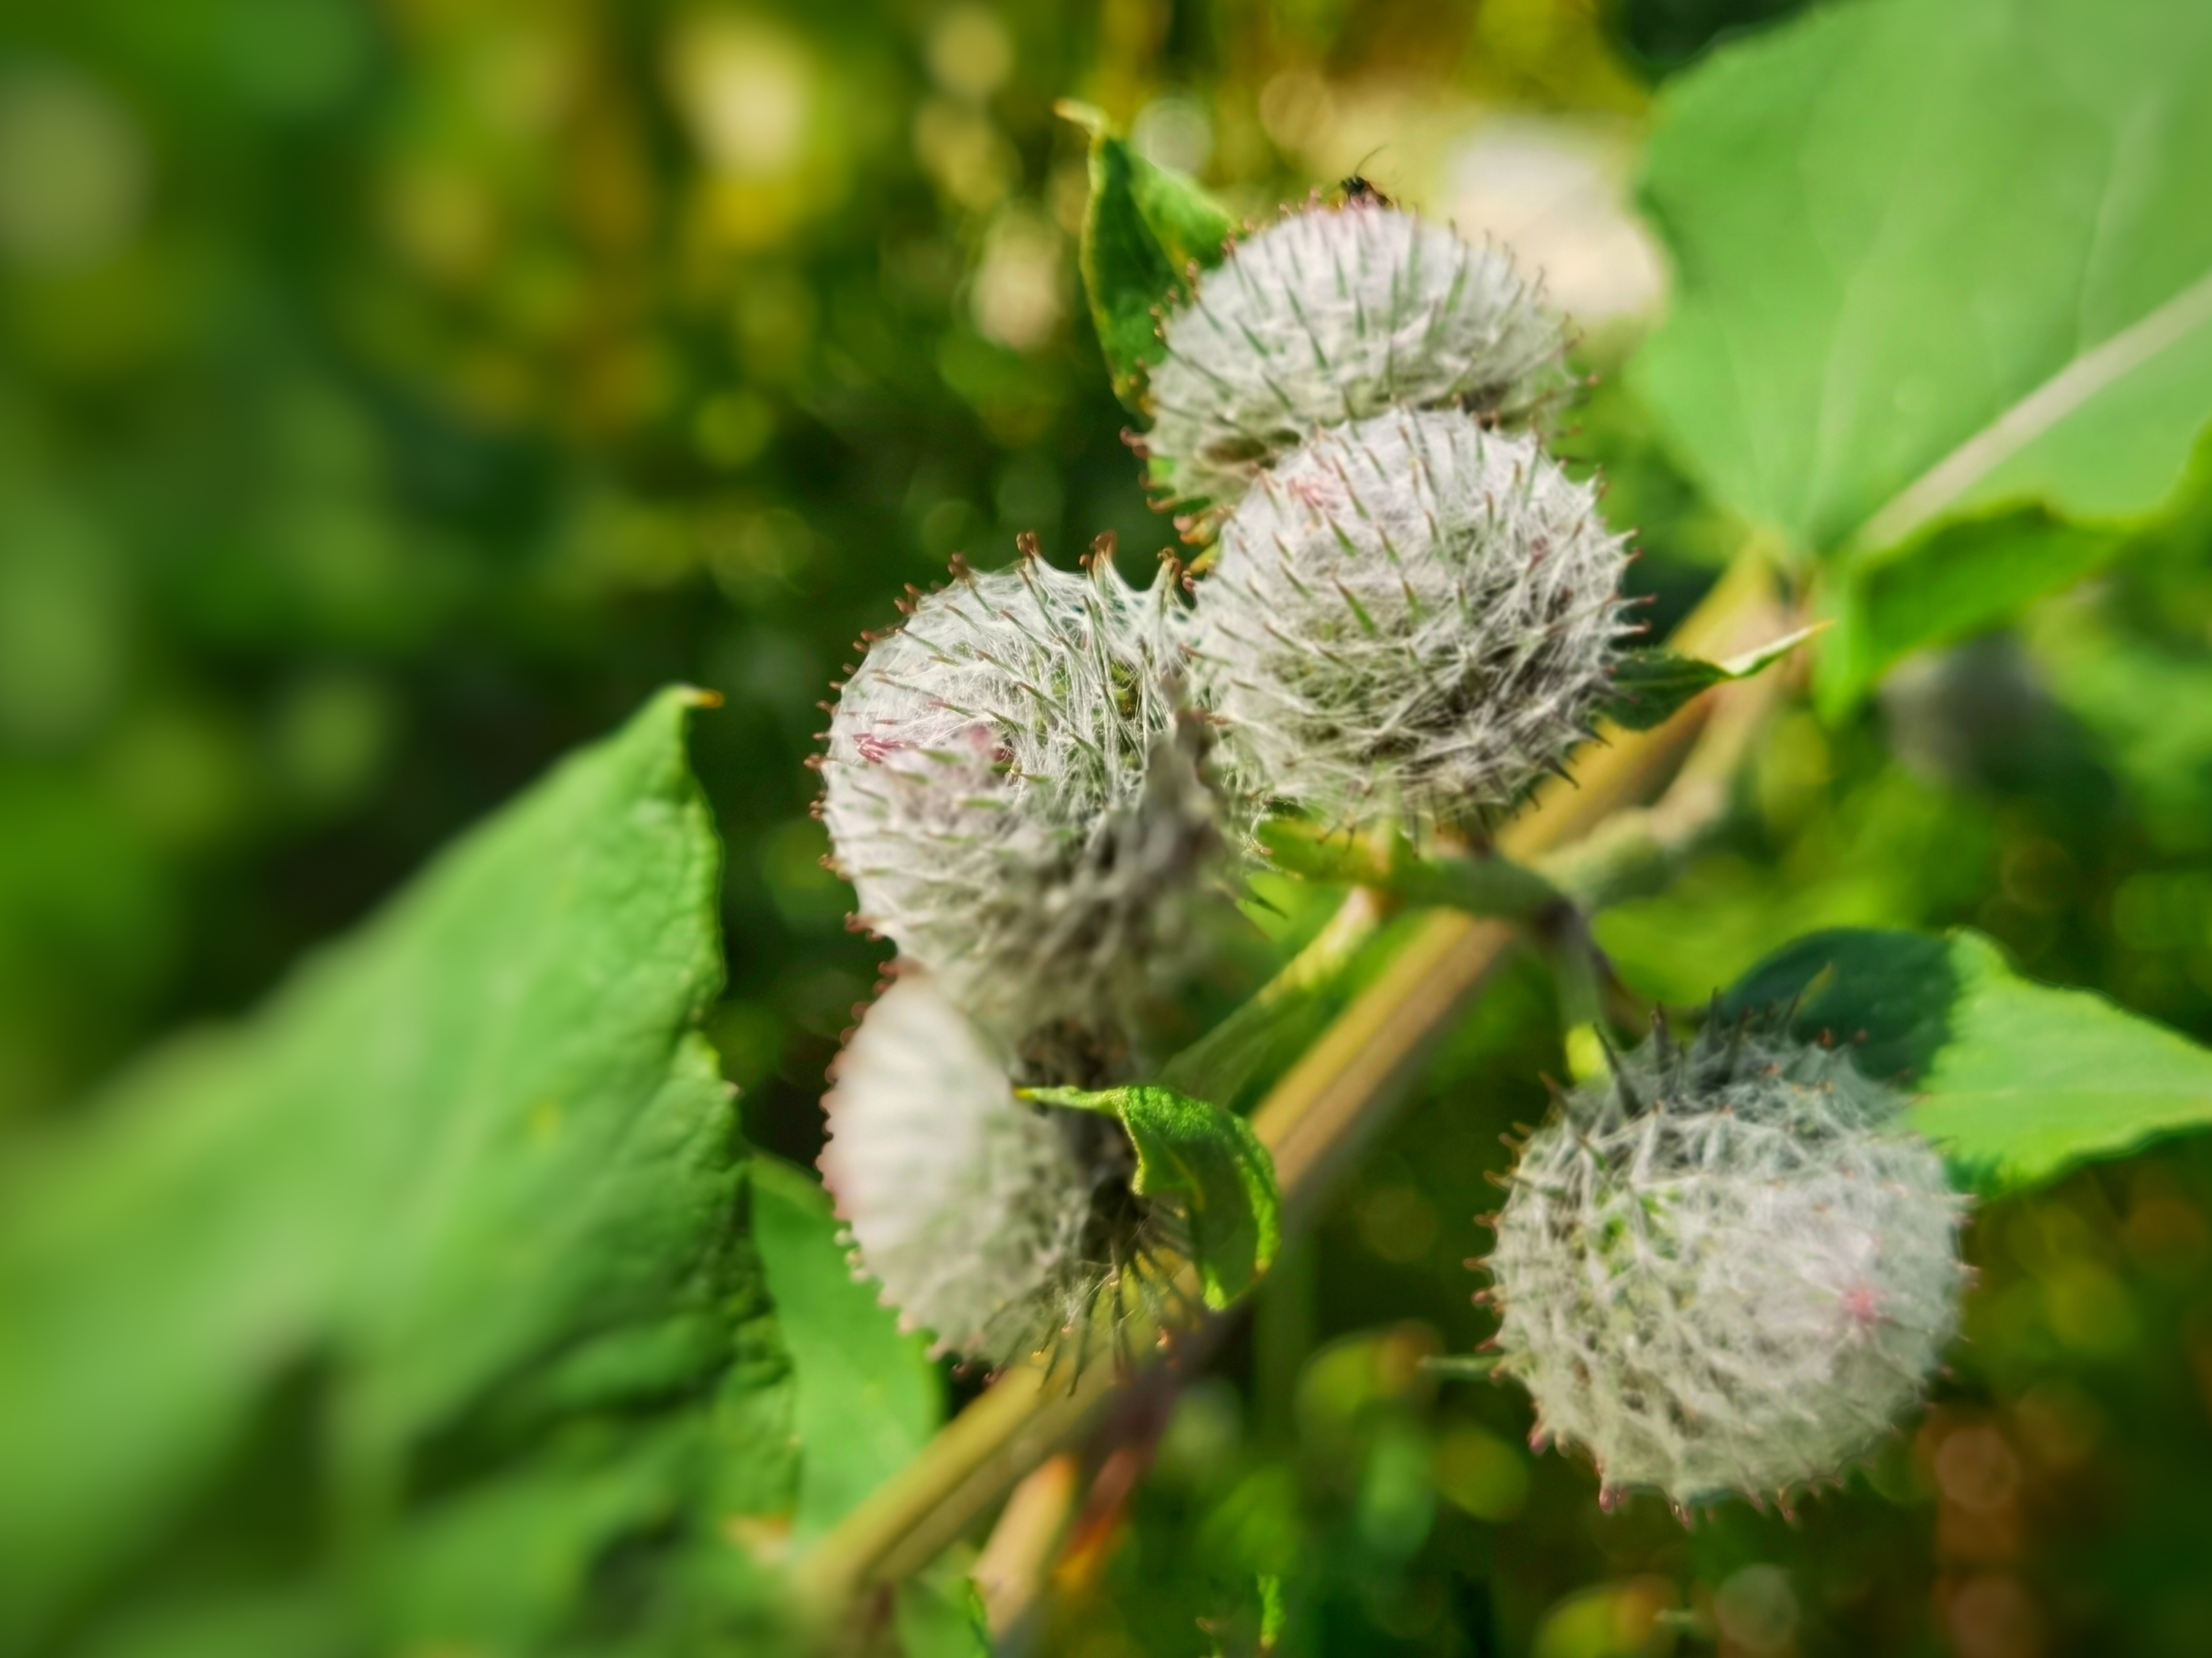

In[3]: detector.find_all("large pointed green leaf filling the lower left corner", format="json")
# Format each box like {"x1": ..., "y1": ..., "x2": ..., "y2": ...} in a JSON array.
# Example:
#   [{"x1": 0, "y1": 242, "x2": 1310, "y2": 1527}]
[{"x1": 0, "y1": 692, "x2": 792, "y2": 1653}]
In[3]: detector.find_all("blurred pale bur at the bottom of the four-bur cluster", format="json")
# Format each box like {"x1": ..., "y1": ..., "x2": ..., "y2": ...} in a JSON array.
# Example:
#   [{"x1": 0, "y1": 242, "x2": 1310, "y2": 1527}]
[{"x1": 821, "y1": 973, "x2": 1148, "y2": 1366}]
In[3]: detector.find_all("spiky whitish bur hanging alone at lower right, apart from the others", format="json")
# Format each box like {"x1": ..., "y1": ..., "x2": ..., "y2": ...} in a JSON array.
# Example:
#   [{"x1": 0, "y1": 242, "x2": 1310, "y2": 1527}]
[{"x1": 1486, "y1": 1019, "x2": 1964, "y2": 1508}]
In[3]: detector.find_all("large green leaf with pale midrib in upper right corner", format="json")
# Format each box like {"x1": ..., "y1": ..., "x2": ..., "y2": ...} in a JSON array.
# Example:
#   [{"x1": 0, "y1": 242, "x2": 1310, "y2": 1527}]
[{"x1": 1637, "y1": 0, "x2": 2212, "y2": 705}]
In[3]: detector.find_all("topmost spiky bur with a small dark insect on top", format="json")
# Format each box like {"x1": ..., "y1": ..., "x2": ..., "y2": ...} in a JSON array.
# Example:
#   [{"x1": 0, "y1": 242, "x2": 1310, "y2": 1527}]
[{"x1": 1143, "y1": 201, "x2": 1566, "y2": 507}]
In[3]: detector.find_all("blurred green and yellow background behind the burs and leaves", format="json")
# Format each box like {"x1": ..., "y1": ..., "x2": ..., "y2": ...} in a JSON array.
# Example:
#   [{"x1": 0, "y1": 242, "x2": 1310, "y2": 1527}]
[{"x1": 12, "y1": 0, "x2": 2212, "y2": 1658}]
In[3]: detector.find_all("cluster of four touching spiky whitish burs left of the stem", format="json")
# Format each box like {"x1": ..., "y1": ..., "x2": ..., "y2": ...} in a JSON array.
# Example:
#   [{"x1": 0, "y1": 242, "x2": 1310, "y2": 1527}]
[{"x1": 821, "y1": 179, "x2": 1626, "y2": 1364}]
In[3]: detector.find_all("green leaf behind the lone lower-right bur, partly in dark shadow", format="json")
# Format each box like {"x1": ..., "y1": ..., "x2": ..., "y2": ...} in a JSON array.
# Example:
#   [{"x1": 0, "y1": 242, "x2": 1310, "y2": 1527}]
[{"x1": 1721, "y1": 930, "x2": 2212, "y2": 1191}]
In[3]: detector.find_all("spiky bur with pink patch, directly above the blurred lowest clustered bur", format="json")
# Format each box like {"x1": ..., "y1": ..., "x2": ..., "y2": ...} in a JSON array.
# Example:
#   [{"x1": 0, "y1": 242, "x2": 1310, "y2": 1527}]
[{"x1": 823, "y1": 555, "x2": 1218, "y2": 1043}]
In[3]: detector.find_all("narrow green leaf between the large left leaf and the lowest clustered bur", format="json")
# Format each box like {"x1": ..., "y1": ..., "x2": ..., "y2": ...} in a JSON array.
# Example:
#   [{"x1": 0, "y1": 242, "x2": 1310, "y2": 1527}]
[{"x1": 752, "y1": 1154, "x2": 944, "y2": 1545}]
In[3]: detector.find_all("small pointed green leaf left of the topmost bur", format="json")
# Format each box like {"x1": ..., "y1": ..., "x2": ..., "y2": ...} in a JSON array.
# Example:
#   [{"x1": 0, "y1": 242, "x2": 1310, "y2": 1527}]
[{"x1": 1057, "y1": 101, "x2": 1238, "y2": 414}]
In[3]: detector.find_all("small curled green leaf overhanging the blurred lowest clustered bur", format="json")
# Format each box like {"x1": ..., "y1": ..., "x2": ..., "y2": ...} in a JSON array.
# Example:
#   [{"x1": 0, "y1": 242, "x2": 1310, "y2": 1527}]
[{"x1": 1022, "y1": 1083, "x2": 1283, "y2": 1309}]
